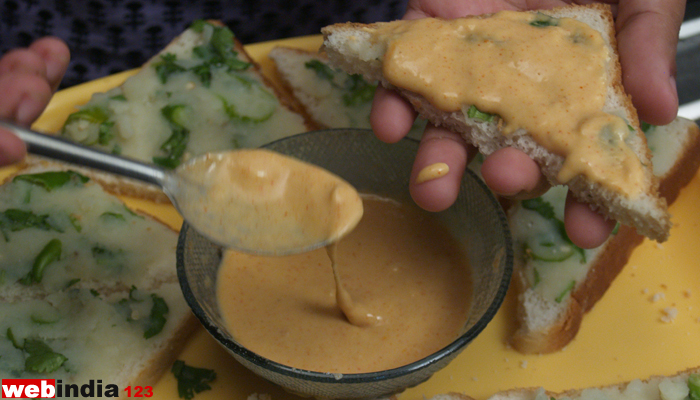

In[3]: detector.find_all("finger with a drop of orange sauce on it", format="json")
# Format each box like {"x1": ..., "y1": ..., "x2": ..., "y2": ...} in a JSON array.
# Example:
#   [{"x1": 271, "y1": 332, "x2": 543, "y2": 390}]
[{"x1": 409, "y1": 125, "x2": 469, "y2": 211}]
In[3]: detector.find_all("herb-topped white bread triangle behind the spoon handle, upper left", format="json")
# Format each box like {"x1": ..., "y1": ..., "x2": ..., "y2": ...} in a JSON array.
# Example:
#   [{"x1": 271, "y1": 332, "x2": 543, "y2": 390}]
[{"x1": 61, "y1": 21, "x2": 314, "y2": 202}]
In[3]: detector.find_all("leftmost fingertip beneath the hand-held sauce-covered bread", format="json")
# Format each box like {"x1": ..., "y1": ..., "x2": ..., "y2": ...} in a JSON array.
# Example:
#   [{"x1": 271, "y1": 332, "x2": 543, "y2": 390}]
[{"x1": 369, "y1": 86, "x2": 416, "y2": 143}]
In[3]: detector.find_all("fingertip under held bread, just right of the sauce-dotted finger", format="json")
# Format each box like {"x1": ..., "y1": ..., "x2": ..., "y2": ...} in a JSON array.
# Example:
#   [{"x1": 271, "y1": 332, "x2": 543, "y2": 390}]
[{"x1": 481, "y1": 147, "x2": 549, "y2": 198}]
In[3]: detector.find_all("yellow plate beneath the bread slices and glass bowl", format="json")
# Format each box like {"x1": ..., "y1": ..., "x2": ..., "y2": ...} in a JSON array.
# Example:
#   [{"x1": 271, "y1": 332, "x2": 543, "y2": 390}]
[{"x1": 8, "y1": 36, "x2": 700, "y2": 400}]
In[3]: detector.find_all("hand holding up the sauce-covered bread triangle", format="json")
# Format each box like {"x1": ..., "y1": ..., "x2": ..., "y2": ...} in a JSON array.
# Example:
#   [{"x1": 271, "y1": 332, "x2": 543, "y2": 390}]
[{"x1": 370, "y1": 0, "x2": 685, "y2": 248}]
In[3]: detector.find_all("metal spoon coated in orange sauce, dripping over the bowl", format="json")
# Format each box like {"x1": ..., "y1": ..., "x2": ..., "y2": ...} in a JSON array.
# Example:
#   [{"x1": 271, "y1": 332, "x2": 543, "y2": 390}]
[{"x1": 0, "y1": 121, "x2": 362, "y2": 255}]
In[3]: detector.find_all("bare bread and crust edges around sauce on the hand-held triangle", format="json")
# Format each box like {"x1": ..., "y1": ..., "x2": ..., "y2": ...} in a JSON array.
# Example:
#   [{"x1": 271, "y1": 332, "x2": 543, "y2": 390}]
[{"x1": 322, "y1": 4, "x2": 671, "y2": 241}]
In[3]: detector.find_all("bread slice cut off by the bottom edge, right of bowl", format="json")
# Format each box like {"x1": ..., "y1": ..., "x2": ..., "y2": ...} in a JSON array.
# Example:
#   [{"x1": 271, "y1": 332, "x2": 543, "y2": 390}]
[{"x1": 430, "y1": 368, "x2": 700, "y2": 400}]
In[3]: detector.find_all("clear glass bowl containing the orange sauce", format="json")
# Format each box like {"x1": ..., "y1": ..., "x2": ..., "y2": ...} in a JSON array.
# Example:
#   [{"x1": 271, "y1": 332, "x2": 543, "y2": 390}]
[{"x1": 177, "y1": 129, "x2": 513, "y2": 399}]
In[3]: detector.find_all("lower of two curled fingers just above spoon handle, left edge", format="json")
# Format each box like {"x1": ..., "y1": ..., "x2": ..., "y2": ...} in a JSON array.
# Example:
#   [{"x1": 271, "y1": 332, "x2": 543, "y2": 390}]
[{"x1": 0, "y1": 71, "x2": 52, "y2": 126}]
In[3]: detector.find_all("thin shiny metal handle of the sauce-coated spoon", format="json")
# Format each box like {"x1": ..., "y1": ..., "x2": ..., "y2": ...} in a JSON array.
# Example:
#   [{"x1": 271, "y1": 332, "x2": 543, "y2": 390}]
[{"x1": 0, "y1": 120, "x2": 167, "y2": 187}]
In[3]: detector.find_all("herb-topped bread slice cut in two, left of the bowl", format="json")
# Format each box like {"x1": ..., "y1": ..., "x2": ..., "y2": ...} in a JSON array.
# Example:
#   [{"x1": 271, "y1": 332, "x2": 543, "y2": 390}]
[{"x1": 0, "y1": 162, "x2": 198, "y2": 395}]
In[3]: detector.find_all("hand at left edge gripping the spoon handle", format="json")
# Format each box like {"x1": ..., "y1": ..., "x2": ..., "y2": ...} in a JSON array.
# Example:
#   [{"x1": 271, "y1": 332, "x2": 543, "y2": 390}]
[{"x1": 0, "y1": 37, "x2": 70, "y2": 166}]
